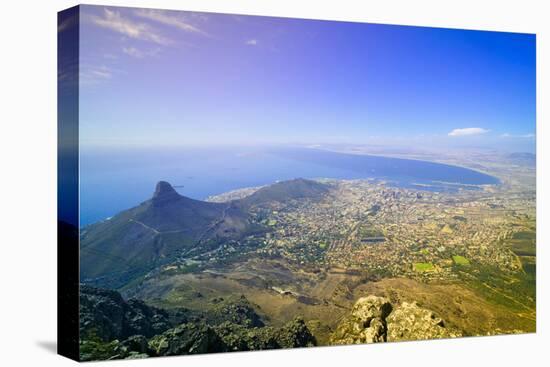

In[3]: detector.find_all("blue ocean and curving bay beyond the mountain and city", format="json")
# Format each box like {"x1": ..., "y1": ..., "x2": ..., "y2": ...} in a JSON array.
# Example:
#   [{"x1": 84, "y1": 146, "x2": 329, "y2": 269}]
[{"x1": 80, "y1": 147, "x2": 499, "y2": 226}]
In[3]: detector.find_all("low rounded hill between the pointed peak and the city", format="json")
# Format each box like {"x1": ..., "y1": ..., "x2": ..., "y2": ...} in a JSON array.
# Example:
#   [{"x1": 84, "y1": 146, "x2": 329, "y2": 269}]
[{"x1": 239, "y1": 178, "x2": 329, "y2": 207}]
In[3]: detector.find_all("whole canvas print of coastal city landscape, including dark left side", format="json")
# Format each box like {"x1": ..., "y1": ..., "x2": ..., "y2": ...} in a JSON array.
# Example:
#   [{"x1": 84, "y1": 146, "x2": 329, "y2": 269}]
[{"x1": 58, "y1": 6, "x2": 536, "y2": 361}]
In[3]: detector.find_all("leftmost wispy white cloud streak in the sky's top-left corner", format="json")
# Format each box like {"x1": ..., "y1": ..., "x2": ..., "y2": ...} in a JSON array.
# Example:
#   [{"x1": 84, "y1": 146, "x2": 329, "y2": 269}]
[{"x1": 90, "y1": 8, "x2": 174, "y2": 46}]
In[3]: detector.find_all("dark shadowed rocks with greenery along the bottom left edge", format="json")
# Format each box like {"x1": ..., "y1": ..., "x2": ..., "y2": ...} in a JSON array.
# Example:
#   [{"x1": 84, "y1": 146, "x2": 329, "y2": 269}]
[{"x1": 80, "y1": 286, "x2": 317, "y2": 361}]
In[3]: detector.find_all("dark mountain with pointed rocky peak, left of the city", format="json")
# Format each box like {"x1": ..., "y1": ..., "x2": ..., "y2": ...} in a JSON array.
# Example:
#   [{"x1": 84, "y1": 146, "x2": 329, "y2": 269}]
[{"x1": 80, "y1": 181, "x2": 261, "y2": 288}]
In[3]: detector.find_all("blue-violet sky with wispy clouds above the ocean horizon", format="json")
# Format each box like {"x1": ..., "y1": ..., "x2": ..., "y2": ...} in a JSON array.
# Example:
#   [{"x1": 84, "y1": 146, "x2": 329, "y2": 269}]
[{"x1": 71, "y1": 6, "x2": 536, "y2": 152}]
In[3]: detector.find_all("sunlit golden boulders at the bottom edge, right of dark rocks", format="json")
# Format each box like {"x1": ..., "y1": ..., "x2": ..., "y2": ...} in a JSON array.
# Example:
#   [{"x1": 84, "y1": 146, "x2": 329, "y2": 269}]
[{"x1": 330, "y1": 296, "x2": 462, "y2": 344}]
